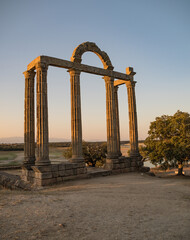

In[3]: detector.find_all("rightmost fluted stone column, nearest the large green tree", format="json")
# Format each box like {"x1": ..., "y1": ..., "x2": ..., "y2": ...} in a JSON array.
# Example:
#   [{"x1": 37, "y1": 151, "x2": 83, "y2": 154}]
[{"x1": 126, "y1": 81, "x2": 139, "y2": 157}]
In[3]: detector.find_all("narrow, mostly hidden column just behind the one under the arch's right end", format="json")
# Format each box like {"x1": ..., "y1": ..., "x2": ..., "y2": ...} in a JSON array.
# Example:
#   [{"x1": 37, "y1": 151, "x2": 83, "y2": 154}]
[{"x1": 114, "y1": 86, "x2": 122, "y2": 156}]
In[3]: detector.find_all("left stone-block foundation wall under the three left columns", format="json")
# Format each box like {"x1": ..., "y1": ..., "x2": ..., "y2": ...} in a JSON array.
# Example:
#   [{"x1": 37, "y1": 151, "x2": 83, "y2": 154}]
[{"x1": 22, "y1": 162, "x2": 87, "y2": 186}]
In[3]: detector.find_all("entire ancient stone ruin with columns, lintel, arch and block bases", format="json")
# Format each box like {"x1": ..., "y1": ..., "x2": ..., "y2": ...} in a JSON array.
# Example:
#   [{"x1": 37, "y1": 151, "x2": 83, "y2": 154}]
[{"x1": 22, "y1": 42, "x2": 143, "y2": 186}]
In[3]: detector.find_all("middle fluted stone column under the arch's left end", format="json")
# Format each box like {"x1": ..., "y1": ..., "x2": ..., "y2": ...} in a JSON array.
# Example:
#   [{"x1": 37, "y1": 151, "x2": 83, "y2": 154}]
[{"x1": 68, "y1": 69, "x2": 84, "y2": 162}]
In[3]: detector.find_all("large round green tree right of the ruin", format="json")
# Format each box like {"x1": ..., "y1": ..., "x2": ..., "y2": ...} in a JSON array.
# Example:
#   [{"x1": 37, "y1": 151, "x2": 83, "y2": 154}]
[{"x1": 141, "y1": 111, "x2": 190, "y2": 175}]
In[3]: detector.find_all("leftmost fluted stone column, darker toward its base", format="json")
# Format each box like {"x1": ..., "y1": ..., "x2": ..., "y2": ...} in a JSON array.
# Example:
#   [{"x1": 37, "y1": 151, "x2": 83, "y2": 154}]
[{"x1": 23, "y1": 70, "x2": 35, "y2": 167}]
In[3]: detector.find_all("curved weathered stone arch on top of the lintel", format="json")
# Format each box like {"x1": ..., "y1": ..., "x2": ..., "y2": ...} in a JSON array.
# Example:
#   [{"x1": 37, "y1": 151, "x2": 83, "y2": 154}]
[{"x1": 71, "y1": 42, "x2": 114, "y2": 70}]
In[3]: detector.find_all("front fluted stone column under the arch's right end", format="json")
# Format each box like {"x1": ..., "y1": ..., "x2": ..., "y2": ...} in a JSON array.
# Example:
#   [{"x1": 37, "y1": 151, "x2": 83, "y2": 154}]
[{"x1": 104, "y1": 76, "x2": 118, "y2": 159}]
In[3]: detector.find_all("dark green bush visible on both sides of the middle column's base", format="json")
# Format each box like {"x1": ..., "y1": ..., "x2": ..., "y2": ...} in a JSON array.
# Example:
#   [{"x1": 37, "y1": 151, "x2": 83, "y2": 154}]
[{"x1": 63, "y1": 141, "x2": 107, "y2": 167}]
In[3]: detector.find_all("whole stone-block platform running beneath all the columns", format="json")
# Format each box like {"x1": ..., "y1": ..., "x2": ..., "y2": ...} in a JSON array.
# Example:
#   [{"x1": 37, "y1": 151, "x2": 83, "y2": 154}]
[{"x1": 21, "y1": 157, "x2": 143, "y2": 186}]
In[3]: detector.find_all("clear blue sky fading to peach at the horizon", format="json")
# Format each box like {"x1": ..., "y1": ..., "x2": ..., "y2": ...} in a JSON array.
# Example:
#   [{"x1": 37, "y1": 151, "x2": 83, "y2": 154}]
[{"x1": 0, "y1": 0, "x2": 190, "y2": 140}]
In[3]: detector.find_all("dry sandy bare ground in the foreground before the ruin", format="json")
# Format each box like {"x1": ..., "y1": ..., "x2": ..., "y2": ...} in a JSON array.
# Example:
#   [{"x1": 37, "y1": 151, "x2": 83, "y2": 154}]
[{"x1": 0, "y1": 173, "x2": 190, "y2": 240}]
